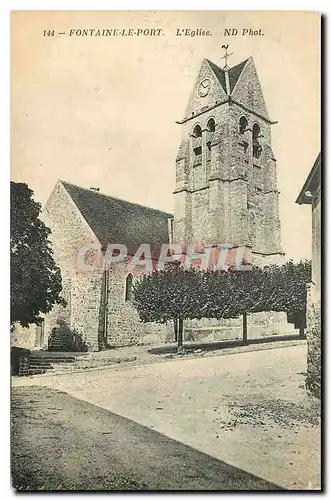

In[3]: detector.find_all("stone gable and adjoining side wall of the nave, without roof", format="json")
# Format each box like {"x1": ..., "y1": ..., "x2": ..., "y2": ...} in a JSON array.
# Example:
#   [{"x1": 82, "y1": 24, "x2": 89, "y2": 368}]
[{"x1": 42, "y1": 182, "x2": 171, "y2": 351}]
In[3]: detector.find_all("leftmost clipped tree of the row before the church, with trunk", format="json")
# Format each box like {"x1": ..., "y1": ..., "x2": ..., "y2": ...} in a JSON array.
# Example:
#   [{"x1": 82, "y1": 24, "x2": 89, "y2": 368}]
[{"x1": 133, "y1": 265, "x2": 203, "y2": 350}]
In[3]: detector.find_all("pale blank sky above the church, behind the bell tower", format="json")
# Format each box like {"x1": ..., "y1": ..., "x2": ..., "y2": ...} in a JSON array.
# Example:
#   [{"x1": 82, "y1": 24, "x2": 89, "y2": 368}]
[{"x1": 11, "y1": 11, "x2": 320, "y2": 260}]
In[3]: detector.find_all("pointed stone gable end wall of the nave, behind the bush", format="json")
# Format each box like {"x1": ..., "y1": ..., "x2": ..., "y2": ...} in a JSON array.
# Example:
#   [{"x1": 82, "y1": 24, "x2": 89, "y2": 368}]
[{"x1": 42, "y1": 182, "x2": 102, "y2": 350}]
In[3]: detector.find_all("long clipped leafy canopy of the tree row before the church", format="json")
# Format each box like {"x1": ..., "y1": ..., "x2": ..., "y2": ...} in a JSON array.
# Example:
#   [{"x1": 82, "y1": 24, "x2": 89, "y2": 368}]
[{"x1": 134, "y1": 260, "x2": 311, "y2": 350}]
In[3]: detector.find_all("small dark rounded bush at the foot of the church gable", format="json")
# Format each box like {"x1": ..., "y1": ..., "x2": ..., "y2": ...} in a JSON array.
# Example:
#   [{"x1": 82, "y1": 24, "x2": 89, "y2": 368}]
[{"x1": 48, "y1": 321, "x2": 87, "y2": 352}]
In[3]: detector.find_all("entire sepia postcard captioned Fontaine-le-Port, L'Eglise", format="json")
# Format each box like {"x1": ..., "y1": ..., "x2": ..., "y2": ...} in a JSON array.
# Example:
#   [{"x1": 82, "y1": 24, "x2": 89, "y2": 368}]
[{"x1": 10, "y1": 10, "x2": 323, "y2": 492}]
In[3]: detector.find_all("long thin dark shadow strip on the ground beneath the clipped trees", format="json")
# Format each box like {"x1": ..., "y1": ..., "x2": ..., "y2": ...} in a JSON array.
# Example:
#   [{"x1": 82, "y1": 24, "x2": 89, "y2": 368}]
[{"x1": 147, "y1": 335, "x2": 306, "y2": 354}]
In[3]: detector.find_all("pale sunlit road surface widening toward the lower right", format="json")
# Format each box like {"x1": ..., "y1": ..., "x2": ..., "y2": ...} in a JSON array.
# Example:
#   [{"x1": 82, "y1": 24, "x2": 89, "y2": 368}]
[{"x1": 14, "y1": 345, "x2": 320, "y2": 489}]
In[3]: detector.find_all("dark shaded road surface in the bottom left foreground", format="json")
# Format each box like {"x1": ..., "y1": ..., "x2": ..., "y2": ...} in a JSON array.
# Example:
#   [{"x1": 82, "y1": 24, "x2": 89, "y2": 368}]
[{"x1": 12, "y1": 387, "x2": 278, "y2": 491}]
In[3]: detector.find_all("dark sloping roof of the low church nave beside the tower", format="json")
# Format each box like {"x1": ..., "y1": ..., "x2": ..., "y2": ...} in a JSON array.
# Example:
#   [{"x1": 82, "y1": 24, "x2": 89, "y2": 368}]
[{"x1": 61, "y1": 181, "x2": 173, "y2": 255}]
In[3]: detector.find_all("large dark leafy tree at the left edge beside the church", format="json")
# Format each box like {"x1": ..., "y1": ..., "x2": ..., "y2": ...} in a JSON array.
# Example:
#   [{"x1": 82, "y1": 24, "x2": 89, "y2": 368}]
[{"x1": 10, "y1": 182, "x2": 65, "y2": 326}]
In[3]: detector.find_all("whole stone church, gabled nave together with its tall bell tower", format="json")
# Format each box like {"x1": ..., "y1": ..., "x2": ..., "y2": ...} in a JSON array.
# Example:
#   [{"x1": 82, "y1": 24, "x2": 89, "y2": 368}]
[{"x1": 15, "y1": 57, "x2": 290, "y2": 350}]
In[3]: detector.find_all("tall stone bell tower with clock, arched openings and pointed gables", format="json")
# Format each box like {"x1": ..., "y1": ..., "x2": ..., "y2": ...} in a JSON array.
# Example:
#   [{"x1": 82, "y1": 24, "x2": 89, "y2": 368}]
[{"x1": 174, "y1": 57, "x2": 284, "y2": 265}]
